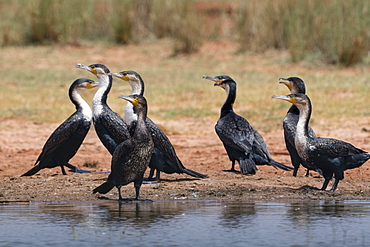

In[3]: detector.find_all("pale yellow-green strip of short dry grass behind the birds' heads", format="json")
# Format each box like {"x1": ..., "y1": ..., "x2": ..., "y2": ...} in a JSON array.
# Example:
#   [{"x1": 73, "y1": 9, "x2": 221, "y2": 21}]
[{"x1": 0, "y1": 40, "x2": 370, "y2": 134}]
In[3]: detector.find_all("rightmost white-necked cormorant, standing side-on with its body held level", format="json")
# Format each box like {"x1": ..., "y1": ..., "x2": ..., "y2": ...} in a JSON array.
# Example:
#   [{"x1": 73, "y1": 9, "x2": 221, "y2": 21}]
[{"x1": 272, "y1": 93, "x2": 370, "y2": 192}]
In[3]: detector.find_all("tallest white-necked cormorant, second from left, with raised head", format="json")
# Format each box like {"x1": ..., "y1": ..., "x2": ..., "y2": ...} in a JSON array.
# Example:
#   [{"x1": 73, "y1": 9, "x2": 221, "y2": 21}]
[{"x1": 76, "y1": 64, "x2": 130, "y2": 155}]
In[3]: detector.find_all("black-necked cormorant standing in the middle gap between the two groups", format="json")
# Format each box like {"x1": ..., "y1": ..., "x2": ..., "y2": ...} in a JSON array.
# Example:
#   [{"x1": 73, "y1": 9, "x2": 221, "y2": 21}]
[{"x1": 203, "y1": 75, "x2": 293, "y2": 174}]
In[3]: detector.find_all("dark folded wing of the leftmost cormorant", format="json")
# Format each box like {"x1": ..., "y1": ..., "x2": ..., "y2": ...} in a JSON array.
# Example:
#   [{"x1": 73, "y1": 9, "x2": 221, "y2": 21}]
[{"x1": 35, "y1": 113, "x2": 81, "y2": 164}]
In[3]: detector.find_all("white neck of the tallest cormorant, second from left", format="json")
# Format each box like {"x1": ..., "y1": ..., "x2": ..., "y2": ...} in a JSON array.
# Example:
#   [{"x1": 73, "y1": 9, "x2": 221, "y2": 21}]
[{"x1": 92, "y1": 75, "x2": 112, "y2": 115}]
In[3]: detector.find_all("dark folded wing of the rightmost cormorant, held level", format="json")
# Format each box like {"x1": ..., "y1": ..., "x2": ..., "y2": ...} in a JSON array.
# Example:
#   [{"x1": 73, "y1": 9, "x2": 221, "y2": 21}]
[{"x1": 309, "y1": 138, "x2": 365, "y2": 157}]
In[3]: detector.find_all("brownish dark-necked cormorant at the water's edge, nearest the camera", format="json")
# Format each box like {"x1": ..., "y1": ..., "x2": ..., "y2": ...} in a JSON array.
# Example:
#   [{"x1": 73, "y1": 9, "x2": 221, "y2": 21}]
[{"x1": 93, "y1": 95, "x2": 154, "y2": 201}]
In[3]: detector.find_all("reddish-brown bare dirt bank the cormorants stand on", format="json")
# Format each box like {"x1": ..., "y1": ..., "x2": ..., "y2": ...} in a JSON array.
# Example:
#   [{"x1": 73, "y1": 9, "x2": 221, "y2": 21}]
[{"x1": 0, "y1": 119, "x2": 370, "y2": 202}]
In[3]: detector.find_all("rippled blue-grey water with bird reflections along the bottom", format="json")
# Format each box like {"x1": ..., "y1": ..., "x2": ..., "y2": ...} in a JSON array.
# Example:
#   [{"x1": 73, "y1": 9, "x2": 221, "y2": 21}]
[{"x1": 0, "y1": 201, "x2": 370, "y2": 247}]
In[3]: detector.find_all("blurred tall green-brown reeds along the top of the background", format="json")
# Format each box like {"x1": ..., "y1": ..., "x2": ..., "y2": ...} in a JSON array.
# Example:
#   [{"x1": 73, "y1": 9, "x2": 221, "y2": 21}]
[{"x1": 0, "y1": 0, "x2": 370, "y2": 66}]
